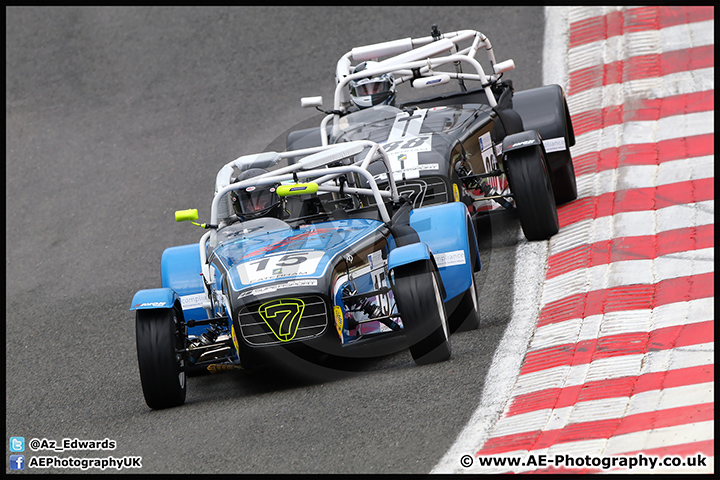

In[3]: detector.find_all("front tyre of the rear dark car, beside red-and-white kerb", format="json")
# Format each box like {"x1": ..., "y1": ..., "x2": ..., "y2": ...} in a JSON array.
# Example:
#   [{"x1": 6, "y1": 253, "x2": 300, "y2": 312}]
[{"x1": 505, "y1": 147, "x2": 560, "y2": 240}]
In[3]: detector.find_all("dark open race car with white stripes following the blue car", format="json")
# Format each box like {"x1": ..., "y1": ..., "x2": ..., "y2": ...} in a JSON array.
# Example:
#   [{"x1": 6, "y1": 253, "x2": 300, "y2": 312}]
[{"x1": 287, "y1": 26, "x2": 577, "y2": 240}]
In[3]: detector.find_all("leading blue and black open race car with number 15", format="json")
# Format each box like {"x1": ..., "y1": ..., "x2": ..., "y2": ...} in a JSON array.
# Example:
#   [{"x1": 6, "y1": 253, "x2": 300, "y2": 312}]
[{"x1": 131, "y1": 140, "x2": 480, "y2": 409}]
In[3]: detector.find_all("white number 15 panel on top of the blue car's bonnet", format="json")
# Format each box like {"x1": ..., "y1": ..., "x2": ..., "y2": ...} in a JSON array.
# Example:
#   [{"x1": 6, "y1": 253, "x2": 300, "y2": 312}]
[{"x1": 237, "y1": 251, "x2": 323, "y2": 285}]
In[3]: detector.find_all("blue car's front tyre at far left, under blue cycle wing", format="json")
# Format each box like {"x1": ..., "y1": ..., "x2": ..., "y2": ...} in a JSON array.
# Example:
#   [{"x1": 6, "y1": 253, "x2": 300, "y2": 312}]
[{"x1": 135, "y1": 308, "x2": 187, "y2": 410}]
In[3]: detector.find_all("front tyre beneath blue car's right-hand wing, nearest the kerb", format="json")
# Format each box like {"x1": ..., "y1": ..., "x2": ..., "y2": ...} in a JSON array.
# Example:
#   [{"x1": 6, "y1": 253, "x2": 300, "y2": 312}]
[{"x1": 393, "y1": 262, "x2": 452, "y2": 365}]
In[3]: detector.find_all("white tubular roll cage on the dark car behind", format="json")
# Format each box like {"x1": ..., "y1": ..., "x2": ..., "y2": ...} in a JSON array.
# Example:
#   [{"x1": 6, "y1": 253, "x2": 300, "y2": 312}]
[{"x1": 312, "y1": 30, "x2": 515, "y2": 145}]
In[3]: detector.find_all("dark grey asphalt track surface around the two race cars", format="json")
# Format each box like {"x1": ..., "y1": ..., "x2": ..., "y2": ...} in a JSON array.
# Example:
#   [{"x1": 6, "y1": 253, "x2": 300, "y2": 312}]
[{"x1": 5, "y1": 7, "x2": 543, "y2": 473}]
